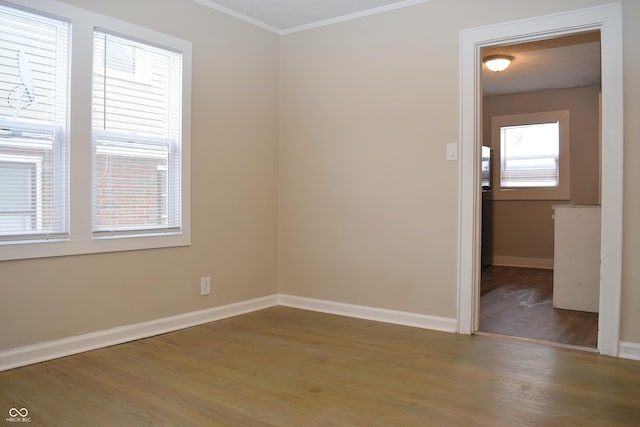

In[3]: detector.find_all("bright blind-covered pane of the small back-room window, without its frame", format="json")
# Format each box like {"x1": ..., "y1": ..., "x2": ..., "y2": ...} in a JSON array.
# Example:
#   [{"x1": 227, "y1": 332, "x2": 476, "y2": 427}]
[{"x1": 500, "y1": 122, "x2": 560, "y2": 188}]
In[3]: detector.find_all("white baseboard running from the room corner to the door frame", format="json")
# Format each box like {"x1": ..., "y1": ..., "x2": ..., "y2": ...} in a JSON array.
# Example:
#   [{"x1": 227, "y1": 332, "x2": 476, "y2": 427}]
[{"x1": 279, "y1": 294, "x2": 457, "y2": 332}]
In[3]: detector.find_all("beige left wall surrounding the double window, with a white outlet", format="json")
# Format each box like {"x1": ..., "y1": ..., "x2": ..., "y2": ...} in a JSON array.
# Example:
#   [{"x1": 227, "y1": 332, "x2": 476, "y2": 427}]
[{"x1": 0, "y1": 0, "x2": 279, "y2": 349}]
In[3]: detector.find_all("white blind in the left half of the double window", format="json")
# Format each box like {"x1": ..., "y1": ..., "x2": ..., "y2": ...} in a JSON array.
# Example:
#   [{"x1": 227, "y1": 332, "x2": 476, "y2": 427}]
[{"x1": 0, "y1": 5, "x2": 69, "y2": 242}]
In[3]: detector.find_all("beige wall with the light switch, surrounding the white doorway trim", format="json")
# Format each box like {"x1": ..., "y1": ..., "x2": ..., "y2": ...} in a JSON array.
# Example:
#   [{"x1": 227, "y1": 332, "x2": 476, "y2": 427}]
[{"x1": 279, "y1": 0, "x2": 640, "y2": 342}]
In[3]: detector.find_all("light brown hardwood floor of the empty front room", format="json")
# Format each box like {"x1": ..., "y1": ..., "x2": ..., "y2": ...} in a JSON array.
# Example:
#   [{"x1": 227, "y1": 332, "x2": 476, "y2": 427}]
[{"x1": 0, "y1": 307, "x2": 640, "y2": 427}]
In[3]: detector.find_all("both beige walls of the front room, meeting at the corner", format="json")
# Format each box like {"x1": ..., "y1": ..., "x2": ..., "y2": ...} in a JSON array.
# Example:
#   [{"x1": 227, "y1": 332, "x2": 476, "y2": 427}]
[{"x1": 0, "y1": 0, "x2": 640, "y2": 349}]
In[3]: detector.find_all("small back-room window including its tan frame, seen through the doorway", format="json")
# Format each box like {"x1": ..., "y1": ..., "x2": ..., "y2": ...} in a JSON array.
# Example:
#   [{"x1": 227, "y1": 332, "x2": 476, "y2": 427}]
[{"x1": 491, "y1": 110, "x2": 570, "y2": 200}]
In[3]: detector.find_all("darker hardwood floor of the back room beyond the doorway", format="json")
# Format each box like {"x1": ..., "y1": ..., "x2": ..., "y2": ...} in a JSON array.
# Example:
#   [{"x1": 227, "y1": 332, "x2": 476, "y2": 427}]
[{"x1": 480, "y1": 266, "x2": 598, "y2": 348}]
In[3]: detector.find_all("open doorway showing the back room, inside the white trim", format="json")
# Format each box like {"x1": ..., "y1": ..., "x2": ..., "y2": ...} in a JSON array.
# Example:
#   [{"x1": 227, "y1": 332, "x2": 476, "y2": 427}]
[{"x1": 478, "y1": 31, "x2": 601, "y2": 348}]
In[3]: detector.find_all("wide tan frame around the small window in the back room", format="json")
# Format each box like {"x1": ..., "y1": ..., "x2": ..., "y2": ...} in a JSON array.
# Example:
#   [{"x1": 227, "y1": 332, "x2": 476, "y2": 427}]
[{"x1": 491, "y1": 110, "x2": 571, "y2": 200}]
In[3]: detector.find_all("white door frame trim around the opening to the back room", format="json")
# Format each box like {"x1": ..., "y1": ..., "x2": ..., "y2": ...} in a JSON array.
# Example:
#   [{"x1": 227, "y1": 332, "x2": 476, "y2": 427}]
[{"x1": 458, "y1": 4, "x2": 623, "y2": 356}]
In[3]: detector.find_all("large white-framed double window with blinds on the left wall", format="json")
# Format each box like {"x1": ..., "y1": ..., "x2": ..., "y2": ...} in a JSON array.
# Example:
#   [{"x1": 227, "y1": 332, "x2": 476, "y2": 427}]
[{"x1": 0, "y1": 0, "x2": 191, "y2": 260}]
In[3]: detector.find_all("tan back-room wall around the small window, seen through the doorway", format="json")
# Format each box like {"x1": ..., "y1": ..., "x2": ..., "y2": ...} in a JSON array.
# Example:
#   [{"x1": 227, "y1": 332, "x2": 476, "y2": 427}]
[{"x1": 482, "y1": 86, "x2": 600, "y2": 260}]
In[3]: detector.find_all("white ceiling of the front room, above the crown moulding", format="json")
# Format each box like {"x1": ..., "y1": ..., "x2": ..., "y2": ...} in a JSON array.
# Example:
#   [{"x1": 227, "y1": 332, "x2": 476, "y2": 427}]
[{"x1": 194, "y1": 0, "x2": 430, "y2": 35}]
